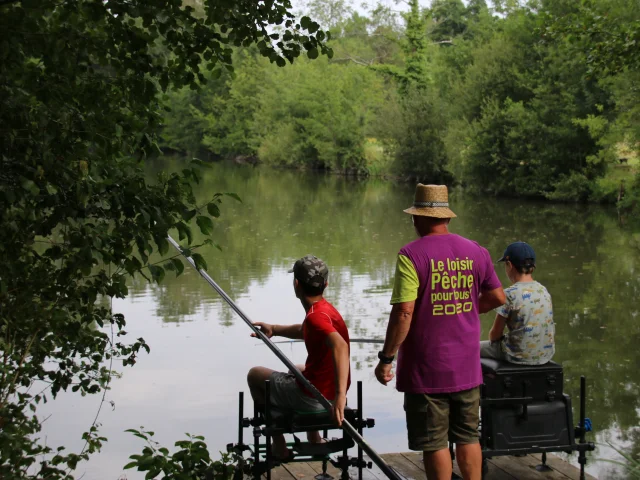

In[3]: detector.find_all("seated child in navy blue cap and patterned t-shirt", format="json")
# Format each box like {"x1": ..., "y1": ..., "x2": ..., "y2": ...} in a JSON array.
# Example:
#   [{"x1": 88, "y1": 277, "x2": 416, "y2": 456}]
[{"x1": 480, "y1": 242, "x2": 555, "y2": 365}]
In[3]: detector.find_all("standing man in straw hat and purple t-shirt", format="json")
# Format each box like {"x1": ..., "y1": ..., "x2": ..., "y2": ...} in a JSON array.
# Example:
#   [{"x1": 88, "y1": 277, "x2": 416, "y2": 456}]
[{"x1": 375, "y1": 184, "x2": 505, "y2": 480}]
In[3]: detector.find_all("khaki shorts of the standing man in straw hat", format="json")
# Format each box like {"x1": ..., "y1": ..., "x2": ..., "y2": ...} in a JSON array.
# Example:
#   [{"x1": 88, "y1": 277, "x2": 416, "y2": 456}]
[{"x1": 404, "y1": 387, "x2": 480, "y2": 452}]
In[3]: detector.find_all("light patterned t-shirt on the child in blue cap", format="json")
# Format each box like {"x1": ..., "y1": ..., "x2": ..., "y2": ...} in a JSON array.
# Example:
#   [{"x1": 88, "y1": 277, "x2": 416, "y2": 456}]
[{"x1": 496, "y1": 281, "x2": 556, "y2": 365}]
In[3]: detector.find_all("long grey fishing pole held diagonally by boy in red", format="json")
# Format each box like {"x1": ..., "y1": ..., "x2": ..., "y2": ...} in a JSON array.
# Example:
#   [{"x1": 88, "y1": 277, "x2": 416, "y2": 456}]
[{"x1": 167, "y1": 235, "x2": 402, "y2": 480}]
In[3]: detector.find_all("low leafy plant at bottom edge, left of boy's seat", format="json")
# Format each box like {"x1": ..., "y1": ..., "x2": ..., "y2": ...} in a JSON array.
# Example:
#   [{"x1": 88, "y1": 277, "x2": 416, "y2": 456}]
[{"x1": 124, "y1": 427, "x2": 245, "y2": 480}]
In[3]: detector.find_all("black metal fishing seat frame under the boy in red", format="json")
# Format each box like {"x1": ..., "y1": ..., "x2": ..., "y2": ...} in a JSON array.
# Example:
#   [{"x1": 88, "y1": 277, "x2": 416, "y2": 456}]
[{"x1": 227, "y1": 380, "x2": 375, "y2": 480}]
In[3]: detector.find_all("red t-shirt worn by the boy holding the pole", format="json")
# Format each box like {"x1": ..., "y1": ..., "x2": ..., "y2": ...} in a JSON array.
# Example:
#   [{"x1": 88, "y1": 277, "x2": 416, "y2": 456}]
[{"x1": 302, "y1": 299, "x2": 351, "y2": 400}]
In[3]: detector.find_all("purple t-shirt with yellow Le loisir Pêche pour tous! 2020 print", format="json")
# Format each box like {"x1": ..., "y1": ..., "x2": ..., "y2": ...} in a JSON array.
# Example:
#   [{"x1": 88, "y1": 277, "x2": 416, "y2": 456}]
[{"x1": 396, "y1": 234, "x2": 501, "y2": 393}]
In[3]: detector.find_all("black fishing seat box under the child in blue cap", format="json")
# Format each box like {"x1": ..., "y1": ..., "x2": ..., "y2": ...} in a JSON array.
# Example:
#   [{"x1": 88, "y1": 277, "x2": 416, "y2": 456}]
[{"x1": 481, "y1": 358, "x2": 574, "y2": 456}]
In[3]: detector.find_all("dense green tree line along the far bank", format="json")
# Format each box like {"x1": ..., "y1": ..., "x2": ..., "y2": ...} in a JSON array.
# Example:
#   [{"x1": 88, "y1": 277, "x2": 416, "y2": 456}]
[{"x1": 163, "y1": 0, "x2": 640, "y2": 208}]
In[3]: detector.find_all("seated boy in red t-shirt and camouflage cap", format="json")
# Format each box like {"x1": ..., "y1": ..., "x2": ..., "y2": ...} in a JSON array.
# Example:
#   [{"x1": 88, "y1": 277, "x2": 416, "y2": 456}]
[{"x1": 247, "y1": 255, "x2": 351, "y2": 460}]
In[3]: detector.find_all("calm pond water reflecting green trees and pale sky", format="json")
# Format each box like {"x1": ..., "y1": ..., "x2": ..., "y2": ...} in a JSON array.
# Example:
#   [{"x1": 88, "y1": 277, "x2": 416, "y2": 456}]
[{"x1": 42, "y1": 160, "x2": 640, "y2": 480}]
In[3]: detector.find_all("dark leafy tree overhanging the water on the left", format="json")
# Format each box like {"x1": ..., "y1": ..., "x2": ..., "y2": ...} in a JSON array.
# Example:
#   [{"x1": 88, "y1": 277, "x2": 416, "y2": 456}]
[{"x1": 0, "y1": 0, "x2": 331, "y2": 479}]
